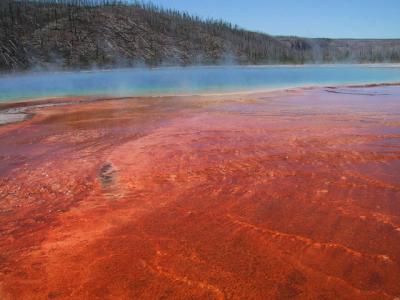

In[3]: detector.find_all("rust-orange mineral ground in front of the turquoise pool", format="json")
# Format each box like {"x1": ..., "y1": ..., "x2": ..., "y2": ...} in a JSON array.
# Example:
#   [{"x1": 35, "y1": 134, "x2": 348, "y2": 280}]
[{"x1": 0, "y1": 87, "x2": 400, "y2": 300}]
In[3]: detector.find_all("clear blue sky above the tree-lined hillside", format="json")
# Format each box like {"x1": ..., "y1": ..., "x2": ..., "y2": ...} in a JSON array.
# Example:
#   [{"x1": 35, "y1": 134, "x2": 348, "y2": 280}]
[{"x1": 138, "y1": 0, "x2": 400, "y2": 38}]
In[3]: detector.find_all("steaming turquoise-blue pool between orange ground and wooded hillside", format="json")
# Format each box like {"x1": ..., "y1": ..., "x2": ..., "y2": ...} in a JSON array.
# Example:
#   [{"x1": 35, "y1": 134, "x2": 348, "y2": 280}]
[{"x1": 0, "y1": 65, "x2": 400, "y2": 102}]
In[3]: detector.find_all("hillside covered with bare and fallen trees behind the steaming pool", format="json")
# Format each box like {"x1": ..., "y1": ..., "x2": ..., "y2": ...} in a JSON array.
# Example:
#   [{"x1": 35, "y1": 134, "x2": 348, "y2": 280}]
[{"x1": 0, "y1": 0, "x2": 400, "y2": 71}]
